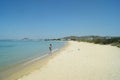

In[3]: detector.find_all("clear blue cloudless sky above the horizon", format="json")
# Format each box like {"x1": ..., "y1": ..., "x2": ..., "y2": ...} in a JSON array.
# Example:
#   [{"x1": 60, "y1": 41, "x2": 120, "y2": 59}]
[{"x1": 0, "y1": 0, "x2": 120, "y2": 39}]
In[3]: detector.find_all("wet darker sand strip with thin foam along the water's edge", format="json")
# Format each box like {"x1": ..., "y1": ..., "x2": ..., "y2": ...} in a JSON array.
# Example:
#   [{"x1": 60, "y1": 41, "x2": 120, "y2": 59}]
[{"x1": 1, "y1": 42, "x2": 68, "y2": 80}]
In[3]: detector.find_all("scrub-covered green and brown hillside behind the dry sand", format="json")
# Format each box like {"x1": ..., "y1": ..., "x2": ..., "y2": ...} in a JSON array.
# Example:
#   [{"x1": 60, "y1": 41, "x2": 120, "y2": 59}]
[{"x1": 61, "y1": 36, "x2": 120, "y2": 47}]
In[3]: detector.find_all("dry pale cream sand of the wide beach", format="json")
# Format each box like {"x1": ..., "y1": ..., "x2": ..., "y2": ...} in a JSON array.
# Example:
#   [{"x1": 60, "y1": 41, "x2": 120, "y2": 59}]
[{"x1": 18, "y1": 41, "x2": 120, "y2": 80}]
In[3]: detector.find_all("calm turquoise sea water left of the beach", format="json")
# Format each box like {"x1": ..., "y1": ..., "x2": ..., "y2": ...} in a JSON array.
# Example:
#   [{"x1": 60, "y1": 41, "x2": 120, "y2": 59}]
[{"x1": 0, "y1": 41, "x2": 65, "y2": 69}]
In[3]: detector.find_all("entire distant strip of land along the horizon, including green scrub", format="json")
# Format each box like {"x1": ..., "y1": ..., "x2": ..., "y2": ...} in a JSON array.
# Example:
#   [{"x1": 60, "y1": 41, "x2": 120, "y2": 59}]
[{"x1": 0, "y1": 35, "x2": 120, "y2": 47}]
